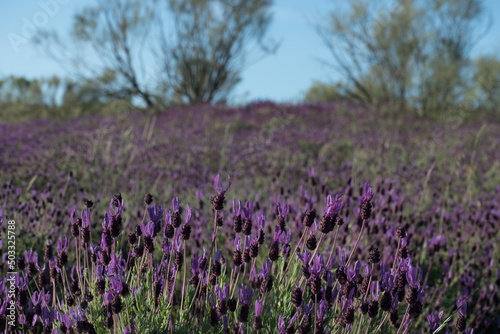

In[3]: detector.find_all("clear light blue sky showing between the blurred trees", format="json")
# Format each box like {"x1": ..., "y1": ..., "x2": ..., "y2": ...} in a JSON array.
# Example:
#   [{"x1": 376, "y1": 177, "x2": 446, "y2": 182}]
[{"x1": 0, "y1": 0, "x2": 500, "y2": 102}]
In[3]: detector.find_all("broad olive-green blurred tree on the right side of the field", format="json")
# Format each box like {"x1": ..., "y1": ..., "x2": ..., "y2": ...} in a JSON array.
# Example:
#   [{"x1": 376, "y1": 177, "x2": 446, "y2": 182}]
[{"x1": 316, "y1": 0, "x2": 488, "y2": 115}]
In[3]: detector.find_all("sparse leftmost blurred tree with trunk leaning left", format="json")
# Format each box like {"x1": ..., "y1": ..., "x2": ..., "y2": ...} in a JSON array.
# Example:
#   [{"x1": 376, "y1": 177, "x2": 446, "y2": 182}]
[{"x1": 35, "y1": 0, "x2": 154, "y2": 107}]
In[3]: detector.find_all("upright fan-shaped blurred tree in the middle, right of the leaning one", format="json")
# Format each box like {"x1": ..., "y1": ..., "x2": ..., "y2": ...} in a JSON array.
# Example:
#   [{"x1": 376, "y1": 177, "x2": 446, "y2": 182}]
[{"x1": 161, "y1": 0, "x2": 273, "y2": 103}]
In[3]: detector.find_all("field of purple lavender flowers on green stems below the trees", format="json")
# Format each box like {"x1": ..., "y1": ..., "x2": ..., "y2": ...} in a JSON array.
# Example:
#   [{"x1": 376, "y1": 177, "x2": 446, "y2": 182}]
[{"x1": 0, "y1": 102, "x2": 500, "y2": 334}]
